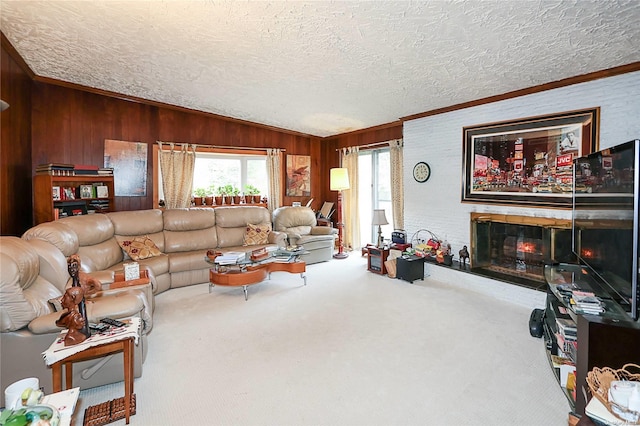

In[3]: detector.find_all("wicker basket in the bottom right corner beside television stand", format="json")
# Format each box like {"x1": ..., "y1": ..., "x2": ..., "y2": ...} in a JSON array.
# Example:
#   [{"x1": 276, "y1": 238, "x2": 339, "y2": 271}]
[{"x1": 587, "y1": 364, "x2": 640, "y2": 424}]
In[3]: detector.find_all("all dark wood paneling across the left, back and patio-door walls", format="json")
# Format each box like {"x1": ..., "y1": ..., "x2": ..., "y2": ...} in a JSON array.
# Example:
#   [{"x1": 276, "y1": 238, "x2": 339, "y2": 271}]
[{"x1": 0, "y1": 35, "x2": 402, "y2": 235}]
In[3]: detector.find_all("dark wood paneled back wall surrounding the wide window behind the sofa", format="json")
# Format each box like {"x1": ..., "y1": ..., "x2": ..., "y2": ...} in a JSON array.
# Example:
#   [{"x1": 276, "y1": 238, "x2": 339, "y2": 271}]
[{"x1": 31, "y1": 82, "x2": 324, "y2": 216}]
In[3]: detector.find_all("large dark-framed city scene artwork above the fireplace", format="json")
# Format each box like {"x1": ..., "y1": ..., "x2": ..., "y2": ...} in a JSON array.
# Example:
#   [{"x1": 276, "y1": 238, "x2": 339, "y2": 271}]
[{"x1": 462, "y1": 107, "x2": 600, "y2": 208}]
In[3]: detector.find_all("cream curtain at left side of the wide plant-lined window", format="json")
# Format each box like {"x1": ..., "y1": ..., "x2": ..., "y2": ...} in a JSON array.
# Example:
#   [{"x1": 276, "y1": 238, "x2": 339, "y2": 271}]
[{"x1": 158, "y1": 142, "x2": 196, "y2": 209}]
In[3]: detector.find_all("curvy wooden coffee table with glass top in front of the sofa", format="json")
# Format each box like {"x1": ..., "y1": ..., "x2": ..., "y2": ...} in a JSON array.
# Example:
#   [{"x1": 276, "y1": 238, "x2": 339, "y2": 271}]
[{"x1": 205, "y1": 249, "x2": 309, "y2": 301}]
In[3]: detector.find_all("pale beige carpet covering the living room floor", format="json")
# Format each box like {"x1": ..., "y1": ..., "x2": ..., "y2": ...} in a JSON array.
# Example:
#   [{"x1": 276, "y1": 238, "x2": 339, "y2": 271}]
[{"x1": 76, "y1": 253, "x2": 569, "y2": 426}]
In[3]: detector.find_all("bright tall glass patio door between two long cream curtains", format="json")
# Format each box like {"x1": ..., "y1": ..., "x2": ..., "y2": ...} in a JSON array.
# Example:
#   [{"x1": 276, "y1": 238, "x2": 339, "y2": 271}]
[{"x1": 358, "y1": 148, "x2": 393, "y2": 245}]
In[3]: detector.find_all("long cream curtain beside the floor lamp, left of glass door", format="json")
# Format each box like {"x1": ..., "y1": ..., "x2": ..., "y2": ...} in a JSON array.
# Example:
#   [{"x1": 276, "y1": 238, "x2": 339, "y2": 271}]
[{"x1": 341, "y1": 146, "x2": 362, "y2": 250}]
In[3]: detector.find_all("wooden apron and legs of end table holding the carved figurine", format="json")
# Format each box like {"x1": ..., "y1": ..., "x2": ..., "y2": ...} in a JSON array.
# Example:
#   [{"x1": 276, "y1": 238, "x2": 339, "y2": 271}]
[{"x1": 51, "y1": 337, "x2": 134, "y2": 424}]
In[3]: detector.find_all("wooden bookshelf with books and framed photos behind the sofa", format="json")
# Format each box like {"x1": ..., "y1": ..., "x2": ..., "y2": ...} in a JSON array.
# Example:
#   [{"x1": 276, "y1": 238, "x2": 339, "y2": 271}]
[{"x1": 33, "y1": 174, "x2": 115, "y2": 225}]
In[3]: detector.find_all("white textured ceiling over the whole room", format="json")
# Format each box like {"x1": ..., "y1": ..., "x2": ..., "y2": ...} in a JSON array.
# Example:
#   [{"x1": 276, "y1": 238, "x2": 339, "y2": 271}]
[{"x1": 0, "y1": 0, "x2": 640, "y2": 136}]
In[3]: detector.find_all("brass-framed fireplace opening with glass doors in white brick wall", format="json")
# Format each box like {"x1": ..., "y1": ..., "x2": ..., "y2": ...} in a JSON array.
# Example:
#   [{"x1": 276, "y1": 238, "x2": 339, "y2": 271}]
[{"x1": 471, "y1": 213, "x2": 575, "y2": 291}]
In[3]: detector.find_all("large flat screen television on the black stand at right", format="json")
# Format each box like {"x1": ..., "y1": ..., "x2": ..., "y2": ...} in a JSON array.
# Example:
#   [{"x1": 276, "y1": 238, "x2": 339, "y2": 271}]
[{"x1": 572, "y1": 140, "x2": 640, "y2": 320}]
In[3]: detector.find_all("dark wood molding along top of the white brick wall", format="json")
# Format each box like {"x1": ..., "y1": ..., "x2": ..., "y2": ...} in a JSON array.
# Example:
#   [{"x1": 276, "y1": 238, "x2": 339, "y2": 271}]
[{"x1": 400, "y1": 62, "x2": 640, "y2": 122}]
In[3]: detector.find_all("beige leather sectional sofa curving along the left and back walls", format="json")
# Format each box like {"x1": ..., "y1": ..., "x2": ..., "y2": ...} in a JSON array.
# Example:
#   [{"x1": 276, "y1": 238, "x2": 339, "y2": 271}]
[{"x1": 0, "y1": 206, "x2": 287, "y2": 406}]
